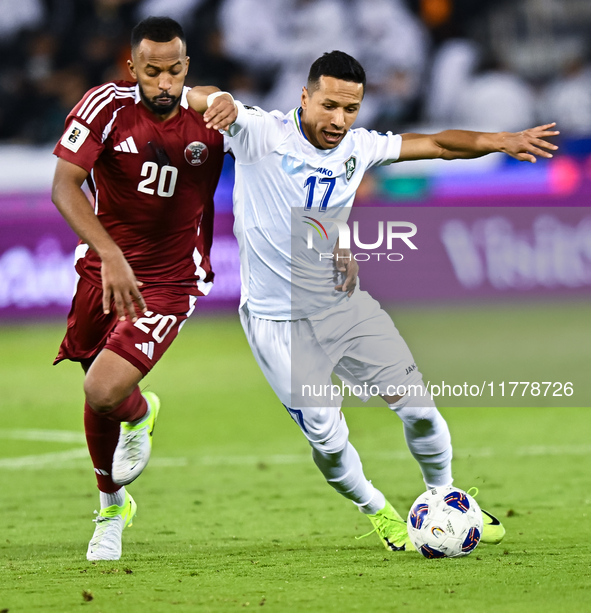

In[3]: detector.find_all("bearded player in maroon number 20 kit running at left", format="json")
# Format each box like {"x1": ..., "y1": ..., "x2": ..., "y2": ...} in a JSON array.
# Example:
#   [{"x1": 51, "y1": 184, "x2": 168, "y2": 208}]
[{"x1": 52, "y1": 17, "x2": 224, "y2": 560}]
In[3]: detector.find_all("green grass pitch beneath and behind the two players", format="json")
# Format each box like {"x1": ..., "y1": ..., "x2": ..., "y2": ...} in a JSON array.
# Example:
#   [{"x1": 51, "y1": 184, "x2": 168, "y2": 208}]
[{"x1": 0, "y1": 303, "x2": 591, "y2": 613}]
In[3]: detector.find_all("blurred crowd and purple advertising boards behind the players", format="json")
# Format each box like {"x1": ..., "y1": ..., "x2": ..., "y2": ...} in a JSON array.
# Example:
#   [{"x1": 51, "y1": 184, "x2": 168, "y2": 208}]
[{"x1": 0, "y1": 0, "x2": 591, "y2": 321}]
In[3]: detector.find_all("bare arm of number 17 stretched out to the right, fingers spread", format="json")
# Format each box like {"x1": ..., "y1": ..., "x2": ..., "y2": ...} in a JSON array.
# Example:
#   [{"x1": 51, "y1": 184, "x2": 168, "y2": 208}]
[{"x1": 398, "y1": 123, "x2": 560, "y2": 163}]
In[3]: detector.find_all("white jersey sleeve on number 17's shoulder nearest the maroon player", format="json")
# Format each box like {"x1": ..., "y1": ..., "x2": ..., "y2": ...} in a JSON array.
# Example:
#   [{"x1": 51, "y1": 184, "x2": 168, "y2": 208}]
[{"x1": 224, "y1": 100, "x2": 285, "y2": 164}]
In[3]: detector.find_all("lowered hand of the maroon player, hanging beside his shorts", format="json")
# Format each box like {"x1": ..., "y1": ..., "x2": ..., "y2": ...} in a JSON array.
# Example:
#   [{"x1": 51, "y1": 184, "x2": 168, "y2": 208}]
[{"x1": 101, "y1": 254, "x2": 147, "y2": 321}]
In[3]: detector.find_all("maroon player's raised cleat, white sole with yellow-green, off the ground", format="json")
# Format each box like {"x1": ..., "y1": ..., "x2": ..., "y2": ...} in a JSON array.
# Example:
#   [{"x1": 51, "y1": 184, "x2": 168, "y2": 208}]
[{"x1": 111, "y1": 392, "x2": 160, "y2": 485}]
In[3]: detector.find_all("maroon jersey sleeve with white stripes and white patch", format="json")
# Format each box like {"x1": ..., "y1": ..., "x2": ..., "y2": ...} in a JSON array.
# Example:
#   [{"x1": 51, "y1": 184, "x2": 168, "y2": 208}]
[{"x1": 53, "y1": 86, "x2": 118, "y2": 172}]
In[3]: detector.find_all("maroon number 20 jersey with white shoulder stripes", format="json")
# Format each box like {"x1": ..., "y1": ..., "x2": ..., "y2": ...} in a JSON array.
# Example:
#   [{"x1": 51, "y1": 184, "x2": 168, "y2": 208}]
[{"x1": 54, "y1": 81, "x2": 224, "y2": 295}]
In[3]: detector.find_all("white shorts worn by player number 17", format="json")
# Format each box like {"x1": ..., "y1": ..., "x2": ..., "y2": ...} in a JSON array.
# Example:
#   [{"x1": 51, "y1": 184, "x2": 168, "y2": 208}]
[{"x1": 240, "y1": 290, "x2": 422, "y2": 409}]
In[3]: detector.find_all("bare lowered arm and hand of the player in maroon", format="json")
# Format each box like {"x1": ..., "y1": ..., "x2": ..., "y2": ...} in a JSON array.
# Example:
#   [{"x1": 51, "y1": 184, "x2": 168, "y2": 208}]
[{"x1": 51, "y1": 159, "x2": 146, "y2": 321}]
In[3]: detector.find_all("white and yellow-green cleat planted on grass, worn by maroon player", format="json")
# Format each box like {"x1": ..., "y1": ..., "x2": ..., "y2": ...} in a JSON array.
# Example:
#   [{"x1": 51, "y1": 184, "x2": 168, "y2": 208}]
[{"x1": 86, "y1": 492, "x2": 137, "y2": 562}]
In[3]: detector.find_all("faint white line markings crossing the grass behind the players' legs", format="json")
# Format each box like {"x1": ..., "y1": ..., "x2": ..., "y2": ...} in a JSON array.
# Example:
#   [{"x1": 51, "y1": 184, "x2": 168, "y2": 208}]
[{"x1": 0, "y1": 430, "x2": 591, "y2": 470}]
